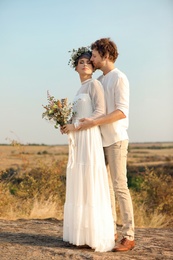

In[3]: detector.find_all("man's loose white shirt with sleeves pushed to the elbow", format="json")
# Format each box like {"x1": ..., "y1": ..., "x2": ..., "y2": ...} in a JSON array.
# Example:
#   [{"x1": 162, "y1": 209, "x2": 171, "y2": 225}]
[{"x1": 98, "y1": 68, "x2": 129, "y2": 147}]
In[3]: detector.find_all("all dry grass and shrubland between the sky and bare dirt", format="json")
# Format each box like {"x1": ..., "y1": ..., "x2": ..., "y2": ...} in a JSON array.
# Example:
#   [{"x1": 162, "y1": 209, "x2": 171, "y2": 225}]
[{"x1": 0, "y1": 142, "x2": 173, "y2": 227}]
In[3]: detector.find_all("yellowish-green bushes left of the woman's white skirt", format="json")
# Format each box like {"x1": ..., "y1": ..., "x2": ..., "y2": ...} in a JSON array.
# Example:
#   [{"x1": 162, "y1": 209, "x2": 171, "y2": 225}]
[{"x1": 1, "y1": 160, "x2": 66, "y2": 203}]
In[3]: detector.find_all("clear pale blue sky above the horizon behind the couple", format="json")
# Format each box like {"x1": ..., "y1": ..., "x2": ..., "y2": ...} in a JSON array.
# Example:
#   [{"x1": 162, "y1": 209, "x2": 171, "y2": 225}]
[{"x1": 0, "y1": 0, "x2": 173, "y2": 145}]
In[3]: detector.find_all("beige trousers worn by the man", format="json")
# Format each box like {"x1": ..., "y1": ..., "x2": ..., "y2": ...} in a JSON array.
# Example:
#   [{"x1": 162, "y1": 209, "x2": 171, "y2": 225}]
[{"x1": 104, "y1": 140, "x2": 134, "y2": 240}]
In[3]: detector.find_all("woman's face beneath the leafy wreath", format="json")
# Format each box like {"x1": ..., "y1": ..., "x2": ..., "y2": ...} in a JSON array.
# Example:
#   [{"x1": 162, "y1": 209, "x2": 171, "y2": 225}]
[{"x1": 76, "y1": 57, "x2": 93, "y2": 75}]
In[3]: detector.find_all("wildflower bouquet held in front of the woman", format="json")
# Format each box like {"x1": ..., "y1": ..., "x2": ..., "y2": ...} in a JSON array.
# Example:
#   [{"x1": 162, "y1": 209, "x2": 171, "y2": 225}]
[{"x1": 42, "y1": 91, "x2": 73, "y2": 128}]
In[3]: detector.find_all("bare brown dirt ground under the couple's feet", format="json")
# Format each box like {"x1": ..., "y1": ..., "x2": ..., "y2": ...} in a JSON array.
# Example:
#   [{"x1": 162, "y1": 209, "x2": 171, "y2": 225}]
[{"x1": 0, "y1": 219, "x2": 173, "y2": 260}]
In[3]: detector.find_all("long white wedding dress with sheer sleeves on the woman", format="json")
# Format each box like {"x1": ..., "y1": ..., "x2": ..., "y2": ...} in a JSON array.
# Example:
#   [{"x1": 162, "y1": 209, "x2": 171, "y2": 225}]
[{"x1": 63, "y1": 79, "x2": 115, "y2": 252}]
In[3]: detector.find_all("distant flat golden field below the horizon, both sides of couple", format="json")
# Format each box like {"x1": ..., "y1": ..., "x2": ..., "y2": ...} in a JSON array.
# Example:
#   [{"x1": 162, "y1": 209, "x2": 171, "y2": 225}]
[{"x1": 0, "y1": 143, "x2": 173, "y2": 171}]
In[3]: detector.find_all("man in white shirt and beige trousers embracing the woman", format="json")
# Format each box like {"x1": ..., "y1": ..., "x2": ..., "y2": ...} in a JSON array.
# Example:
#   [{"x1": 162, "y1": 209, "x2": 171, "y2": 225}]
[{"x1": 78, "y1": 38, "x2": 135, "y2": 252}]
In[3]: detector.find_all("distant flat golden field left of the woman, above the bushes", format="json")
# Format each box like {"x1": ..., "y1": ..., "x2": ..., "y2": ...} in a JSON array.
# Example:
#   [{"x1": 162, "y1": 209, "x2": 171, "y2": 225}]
[{"x1": 0, "y1": 144, "x2": 68, "y2": 171}]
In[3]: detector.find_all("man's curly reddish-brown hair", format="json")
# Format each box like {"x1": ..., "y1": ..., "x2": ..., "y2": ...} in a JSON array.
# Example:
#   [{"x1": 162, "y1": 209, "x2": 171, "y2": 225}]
[{"x1": 91, "y1": 38, "x2": 118, "y2": 62}]
